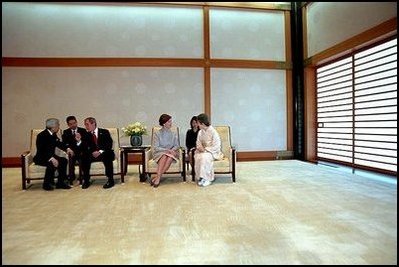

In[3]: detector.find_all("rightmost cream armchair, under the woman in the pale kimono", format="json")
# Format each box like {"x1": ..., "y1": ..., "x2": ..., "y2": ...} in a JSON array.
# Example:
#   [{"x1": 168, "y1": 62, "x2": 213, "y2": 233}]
[{"x1": 191, "y1": 126, "x2": 236, "y2": 183}]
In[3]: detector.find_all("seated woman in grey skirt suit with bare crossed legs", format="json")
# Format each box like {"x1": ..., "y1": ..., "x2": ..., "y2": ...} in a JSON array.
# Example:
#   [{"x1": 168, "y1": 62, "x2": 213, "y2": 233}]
[{"x1": 150, "y1": 114, "x2": 179, "y2": 187}]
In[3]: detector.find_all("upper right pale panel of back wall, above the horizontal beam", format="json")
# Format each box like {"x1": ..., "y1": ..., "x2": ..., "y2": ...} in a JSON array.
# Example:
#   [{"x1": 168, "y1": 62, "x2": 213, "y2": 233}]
[{"x1": 209, "y1": 9, "x2": 285, "y2": 61}]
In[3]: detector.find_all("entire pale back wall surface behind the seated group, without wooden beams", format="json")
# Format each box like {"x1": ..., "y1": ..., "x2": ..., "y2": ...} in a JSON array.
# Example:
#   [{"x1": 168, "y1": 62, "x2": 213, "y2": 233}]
[{"x1": 2, "y1": 3, "x2": 287, "y2": 157}]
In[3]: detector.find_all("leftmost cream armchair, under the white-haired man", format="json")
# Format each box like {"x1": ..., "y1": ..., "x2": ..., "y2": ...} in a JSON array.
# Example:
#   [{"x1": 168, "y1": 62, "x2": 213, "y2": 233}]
[{"x1": 21, "y1": 129, "x2": 68, "y2": 190}]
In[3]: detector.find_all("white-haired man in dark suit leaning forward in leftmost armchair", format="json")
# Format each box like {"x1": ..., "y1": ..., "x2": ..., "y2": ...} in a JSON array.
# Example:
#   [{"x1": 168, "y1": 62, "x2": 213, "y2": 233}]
[{"x1": 33, "y1": 118, "x2": 71, "y2": 190}]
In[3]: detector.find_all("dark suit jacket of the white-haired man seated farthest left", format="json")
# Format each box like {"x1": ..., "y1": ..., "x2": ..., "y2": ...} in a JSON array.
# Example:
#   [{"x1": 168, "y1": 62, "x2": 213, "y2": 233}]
[{"x1": 33, "y1": 129, "x2": 66, "y2": 166}]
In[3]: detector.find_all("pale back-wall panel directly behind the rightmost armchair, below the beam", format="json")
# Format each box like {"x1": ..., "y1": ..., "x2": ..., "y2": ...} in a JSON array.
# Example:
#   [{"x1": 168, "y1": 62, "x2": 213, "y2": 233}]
[{"x1": 211, "y1": 69, "x2": 287, "y2": 151}]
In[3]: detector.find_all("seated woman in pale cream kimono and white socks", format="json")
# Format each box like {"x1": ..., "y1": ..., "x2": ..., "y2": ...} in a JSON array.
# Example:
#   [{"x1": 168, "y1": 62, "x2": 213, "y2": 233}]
[{"x1": 194, "y1": 113, "x2": 223, "y2": 186}]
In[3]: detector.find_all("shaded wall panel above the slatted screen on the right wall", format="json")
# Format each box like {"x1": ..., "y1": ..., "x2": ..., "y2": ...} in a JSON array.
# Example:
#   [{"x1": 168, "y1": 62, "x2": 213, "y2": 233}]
[{"x1": 307, "y1": 2, "x2": 397, "y2": 57}]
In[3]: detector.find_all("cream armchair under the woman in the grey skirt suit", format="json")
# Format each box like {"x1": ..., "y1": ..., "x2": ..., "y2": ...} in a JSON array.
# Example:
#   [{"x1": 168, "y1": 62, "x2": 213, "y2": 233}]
[{"x1": 145, "y1": 126, "x2": 186, "y2": 181}]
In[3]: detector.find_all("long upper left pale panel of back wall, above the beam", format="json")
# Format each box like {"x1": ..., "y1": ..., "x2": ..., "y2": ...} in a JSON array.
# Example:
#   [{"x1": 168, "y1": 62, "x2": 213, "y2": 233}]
[{"x1": 2, "y1": 3, "x2": 203, "y2": 58}]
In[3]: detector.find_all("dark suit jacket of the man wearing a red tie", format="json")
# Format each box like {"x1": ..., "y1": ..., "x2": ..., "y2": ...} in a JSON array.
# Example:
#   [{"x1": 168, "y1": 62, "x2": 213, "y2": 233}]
[{"x1": 81, "y1": 128, "x2": 113, "y2": 154}]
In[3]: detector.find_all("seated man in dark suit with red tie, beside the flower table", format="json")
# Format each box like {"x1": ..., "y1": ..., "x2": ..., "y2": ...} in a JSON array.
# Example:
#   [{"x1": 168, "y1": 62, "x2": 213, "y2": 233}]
[{"x1": 78, "y1": 117, "x2": 115, "y2": 189}]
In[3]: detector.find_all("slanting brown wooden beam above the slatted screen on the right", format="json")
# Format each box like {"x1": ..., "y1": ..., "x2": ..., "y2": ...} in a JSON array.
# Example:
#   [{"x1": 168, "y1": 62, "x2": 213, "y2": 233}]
[{"x1": 305, "y1": 17, "x2": 397, "y2": 66}]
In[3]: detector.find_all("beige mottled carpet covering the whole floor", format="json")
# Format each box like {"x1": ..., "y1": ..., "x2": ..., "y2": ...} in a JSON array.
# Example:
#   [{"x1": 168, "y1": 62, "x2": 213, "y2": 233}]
[{"x1": 2, "y1": 160, "x2": 397, "y2": 264}]
